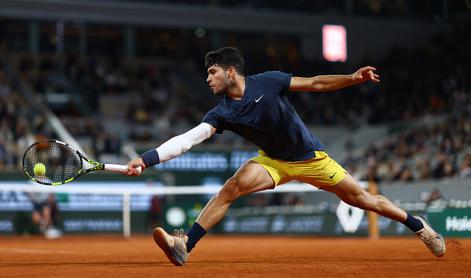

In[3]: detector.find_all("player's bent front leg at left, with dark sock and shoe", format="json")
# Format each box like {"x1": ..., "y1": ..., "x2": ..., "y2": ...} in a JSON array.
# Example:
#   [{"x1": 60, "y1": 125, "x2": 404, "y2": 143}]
[{"x1": 153, "y1": 160, "x2": 275, "y2": 265}]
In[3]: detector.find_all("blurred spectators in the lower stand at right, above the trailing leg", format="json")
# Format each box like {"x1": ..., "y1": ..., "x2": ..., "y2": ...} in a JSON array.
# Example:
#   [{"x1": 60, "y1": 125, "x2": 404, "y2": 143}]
[{"x1": 346, "y1": 111, "x2": 471, "y2": 182}]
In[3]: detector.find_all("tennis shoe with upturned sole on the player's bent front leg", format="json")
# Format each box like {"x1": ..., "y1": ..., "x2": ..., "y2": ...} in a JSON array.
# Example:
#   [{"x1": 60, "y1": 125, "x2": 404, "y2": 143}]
[{"x1": 153, "y1": 227, "x2": 189, "y2": 266}]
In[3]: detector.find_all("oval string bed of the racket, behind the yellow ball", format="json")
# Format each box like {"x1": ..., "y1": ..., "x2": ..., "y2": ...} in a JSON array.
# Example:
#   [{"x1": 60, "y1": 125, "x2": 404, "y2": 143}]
[{"x1": 23, "y1": 141, "x2": 82, "y2": 184}]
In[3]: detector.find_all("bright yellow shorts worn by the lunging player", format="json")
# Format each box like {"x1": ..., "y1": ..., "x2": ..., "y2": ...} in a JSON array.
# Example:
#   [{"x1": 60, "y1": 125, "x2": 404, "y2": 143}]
[{"x1": 251, "y1": 151, "x2": 348, "y2": 187}]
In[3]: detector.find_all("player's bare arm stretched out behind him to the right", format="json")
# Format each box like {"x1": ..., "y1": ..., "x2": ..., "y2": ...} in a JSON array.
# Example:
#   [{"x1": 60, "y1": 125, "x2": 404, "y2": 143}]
[{"x1": 289, "y1": 66, "x2": 379, "y2": 92}]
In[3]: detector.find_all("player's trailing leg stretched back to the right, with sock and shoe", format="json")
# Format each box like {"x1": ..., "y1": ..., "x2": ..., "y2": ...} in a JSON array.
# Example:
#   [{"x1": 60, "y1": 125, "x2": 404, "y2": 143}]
[{"x1": 322, "y1": 174, "x2": 446, "y2": 257}]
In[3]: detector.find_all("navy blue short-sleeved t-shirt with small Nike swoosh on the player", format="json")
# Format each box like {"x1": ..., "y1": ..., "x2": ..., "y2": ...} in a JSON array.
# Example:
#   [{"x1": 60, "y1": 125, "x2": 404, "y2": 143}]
[{"x1": 202, "y1": 71, "x2": 325, "y2": 161}]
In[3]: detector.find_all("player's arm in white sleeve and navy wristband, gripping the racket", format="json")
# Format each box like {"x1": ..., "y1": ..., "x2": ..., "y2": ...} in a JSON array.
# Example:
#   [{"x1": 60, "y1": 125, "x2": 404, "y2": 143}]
[{"x1": 127, "y1": 123, "x2": 216, "y2": 176}]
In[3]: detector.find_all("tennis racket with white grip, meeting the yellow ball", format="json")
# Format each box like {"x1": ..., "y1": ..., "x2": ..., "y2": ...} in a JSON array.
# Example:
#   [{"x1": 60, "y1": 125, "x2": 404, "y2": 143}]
[{"x1": 23, "y1": 140, "x2": 142, "y2": 185}]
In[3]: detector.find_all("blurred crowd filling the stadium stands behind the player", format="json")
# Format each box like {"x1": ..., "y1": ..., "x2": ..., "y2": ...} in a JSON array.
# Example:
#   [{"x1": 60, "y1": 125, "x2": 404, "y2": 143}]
[{"x1": 0, "y1": 17, "x2": 471, "y2": 184}]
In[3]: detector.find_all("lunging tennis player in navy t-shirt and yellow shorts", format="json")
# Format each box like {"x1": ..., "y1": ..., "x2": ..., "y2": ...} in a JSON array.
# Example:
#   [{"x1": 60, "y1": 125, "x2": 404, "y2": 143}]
[{"x1": 128, "y1": 47, "x2": 445, "y2": 265}]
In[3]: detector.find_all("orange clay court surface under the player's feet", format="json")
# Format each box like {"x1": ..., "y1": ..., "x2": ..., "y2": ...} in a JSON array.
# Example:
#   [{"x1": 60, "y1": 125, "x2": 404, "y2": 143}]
[{"x1": 0, "y1": 235, "x2": 471, "y2": 278}]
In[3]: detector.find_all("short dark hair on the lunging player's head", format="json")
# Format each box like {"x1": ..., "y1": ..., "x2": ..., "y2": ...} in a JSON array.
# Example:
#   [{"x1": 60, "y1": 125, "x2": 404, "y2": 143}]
[{"x1": 204, "y1": 47, "x2": 245, "y2": 74}]
